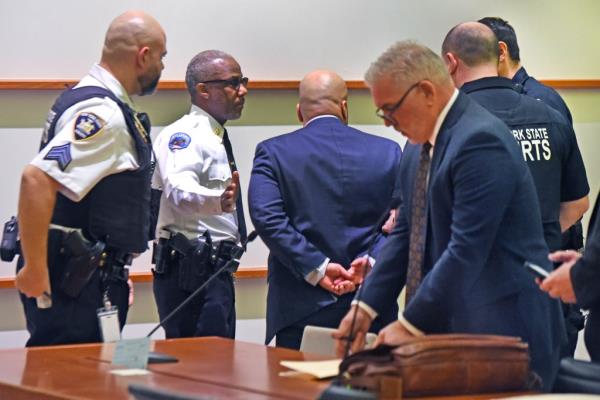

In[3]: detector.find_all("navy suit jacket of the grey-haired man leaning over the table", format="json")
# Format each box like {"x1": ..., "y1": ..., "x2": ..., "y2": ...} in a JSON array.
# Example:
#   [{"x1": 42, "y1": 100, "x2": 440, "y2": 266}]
[{"x1": 363, "y1": 93, "x2": 564, "y2": 384}]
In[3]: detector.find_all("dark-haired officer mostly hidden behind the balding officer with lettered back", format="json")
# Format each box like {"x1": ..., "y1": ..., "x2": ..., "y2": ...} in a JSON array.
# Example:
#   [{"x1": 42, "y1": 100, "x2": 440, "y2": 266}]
[{"x1": 478, "y1": 17, "x2": 583, "y2": 250}]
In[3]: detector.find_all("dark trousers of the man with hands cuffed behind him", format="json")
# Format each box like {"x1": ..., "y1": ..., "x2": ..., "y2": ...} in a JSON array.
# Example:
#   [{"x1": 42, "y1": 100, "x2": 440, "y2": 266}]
[{"x1": 275, "y1": 293, "x2": 398, "y2": 350}]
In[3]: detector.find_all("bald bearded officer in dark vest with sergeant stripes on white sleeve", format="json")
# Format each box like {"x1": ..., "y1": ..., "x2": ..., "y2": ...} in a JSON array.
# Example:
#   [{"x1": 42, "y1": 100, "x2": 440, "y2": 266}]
[{"x1": 16, "y1": 11, "x2": 166, "y2": 346}]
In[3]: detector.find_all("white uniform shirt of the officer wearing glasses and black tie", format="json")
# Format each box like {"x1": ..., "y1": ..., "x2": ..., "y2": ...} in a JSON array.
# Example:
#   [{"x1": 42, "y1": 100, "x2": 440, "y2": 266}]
[{"x1": 153, "y1": 105, "x2": 239, "y2": 242}]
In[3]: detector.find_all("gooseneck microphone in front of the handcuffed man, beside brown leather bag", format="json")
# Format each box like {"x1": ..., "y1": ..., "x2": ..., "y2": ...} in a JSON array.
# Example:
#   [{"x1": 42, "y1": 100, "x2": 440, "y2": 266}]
[{"x1": 317, "y1": 206, "x2": 397, "y2": 400}]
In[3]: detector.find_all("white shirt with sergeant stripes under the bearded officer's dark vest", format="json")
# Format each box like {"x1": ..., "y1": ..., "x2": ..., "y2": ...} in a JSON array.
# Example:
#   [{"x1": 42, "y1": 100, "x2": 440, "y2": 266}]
[{"x1": 31, "y1": 64, "x2": 139, "y2": 201}]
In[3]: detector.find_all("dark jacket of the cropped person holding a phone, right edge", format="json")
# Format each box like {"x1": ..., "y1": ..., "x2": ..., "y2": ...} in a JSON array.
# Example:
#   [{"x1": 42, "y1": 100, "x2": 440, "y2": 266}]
[{"x1": 571, "y1": 195, "x2": 600, "y2": 312}]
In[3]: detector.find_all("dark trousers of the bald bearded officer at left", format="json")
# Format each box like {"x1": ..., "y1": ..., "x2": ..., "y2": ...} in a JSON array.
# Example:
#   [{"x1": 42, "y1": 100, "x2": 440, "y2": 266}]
[{"x1": 17, "y1": 250, "x2": 129, "y2": 347}]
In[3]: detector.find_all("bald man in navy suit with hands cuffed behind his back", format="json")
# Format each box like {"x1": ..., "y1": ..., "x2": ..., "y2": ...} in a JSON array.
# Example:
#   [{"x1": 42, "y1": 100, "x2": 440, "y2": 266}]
[{"x1": 248, "y1": 71, "x2": 400, "y2": 349}]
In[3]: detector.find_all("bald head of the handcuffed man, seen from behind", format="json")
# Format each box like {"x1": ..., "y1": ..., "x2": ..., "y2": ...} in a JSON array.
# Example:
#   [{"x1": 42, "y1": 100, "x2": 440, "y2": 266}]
[{"x1": 298, "y1": 70, "x2": 348, "y2": 122}]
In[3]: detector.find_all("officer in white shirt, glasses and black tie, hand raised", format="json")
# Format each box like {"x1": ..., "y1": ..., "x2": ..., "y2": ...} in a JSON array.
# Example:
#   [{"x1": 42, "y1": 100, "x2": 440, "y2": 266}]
[{"x1": 153, "y1": 50, "x2": 248, "y2": 338}]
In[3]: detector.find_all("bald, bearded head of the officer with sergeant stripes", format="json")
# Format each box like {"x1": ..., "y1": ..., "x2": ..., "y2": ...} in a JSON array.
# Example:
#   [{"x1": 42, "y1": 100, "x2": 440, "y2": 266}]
[{"x1": 101, "y1": 11, "x2": 166, "y2": 94}]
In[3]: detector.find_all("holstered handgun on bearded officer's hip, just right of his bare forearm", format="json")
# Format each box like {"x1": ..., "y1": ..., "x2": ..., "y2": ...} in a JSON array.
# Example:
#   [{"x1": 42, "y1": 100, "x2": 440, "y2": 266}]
[{"x1": 60, "y1": 231, "x2": 106, "y2": 297}]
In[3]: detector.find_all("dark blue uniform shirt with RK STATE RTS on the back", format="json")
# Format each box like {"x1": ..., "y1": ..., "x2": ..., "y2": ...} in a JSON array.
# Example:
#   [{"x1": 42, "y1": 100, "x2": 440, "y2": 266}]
[{"x1": 461, "y1": 77, "x2": 589, "y2": 251}]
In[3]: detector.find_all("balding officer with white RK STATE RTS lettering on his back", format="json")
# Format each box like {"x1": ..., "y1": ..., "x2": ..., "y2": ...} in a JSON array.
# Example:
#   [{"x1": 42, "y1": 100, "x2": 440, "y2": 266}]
[{"x1": 442, "y1": 22, "x2": 589, "y2": 355}]
